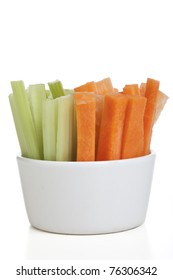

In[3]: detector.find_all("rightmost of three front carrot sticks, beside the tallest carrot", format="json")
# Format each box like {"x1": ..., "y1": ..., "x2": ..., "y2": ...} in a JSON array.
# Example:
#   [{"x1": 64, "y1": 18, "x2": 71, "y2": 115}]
[{"x1": 121, "y1": 95, "x2": 147, "y2": 159}]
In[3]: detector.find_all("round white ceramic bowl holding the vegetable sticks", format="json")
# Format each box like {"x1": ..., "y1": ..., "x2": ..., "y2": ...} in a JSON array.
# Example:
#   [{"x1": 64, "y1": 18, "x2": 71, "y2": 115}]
[{"x1": 17, "y1": 152, "x2": 155, "y2": 234}]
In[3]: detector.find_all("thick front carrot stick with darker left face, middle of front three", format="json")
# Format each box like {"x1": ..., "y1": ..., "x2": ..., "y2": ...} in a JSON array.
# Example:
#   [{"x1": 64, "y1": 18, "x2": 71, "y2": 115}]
[{"x1": 96, "y1": 93, "x2": 128, "y2": 160}]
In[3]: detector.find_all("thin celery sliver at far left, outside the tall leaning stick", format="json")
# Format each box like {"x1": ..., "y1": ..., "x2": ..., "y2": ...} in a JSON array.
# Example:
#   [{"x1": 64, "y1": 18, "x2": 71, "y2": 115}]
[{"x1": 9, "y1": 94, "x2": 28, "y2": 157}]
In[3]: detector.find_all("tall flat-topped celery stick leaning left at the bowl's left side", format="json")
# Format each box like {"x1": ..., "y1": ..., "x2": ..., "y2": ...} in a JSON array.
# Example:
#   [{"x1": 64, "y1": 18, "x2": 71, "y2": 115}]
[{"x1": 11, "y1": 81, "x2": 41, "y2": 159}]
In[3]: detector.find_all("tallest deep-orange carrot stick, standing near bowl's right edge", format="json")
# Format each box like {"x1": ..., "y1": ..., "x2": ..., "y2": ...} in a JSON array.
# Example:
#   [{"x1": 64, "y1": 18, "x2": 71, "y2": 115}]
[{"x1": 144, "y1": 78, "x2": 159, "y2": 155}]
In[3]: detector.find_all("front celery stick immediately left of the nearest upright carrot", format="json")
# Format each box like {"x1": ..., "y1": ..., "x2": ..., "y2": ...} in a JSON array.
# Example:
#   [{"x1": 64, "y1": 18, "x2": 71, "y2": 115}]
[{"x1": 56, "y1": 94, "x2": 74, "y2": 161}]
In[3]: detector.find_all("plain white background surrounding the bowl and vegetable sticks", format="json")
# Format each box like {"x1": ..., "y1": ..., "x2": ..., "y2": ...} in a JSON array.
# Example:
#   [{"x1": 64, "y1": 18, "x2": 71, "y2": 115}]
[{"x1": 0, "y1": 0, "x2": 173, "y2": 278}]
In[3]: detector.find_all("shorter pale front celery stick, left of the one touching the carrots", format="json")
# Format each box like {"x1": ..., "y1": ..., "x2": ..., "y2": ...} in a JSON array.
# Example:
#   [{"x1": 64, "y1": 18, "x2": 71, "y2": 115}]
[{"x1": 42, "y1": 99, "x2": 58, "y2": 160}]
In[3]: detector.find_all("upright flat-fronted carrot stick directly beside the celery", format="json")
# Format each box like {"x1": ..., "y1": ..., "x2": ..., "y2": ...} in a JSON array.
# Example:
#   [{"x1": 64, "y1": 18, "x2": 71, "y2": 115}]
[{"x1": 75, "y1": 92, "x2": 96, "y2": 161}]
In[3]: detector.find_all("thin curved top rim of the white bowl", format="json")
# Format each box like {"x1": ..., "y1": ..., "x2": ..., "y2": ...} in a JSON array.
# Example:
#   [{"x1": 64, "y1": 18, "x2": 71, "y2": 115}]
[{"x1": 16, "y1": 150, "x2": 156, "y2": 166}]
